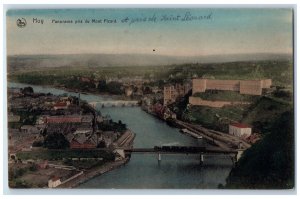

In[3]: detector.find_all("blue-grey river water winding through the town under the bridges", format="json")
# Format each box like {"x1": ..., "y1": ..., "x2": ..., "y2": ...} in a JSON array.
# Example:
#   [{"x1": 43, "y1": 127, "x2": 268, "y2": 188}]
[{"x1": 8, "y1": 83, "x2": 232, "y2": 189}]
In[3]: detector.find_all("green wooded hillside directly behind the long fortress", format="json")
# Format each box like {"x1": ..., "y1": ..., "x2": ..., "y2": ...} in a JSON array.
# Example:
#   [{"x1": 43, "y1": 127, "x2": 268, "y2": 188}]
[{"x1": 168, "y1": 60, "x2": 293, "y2": 88}]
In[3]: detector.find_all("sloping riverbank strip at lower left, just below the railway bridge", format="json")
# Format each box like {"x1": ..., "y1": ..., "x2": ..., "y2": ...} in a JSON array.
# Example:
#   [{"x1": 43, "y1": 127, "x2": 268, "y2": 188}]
[{"x1": 56, "y1": 158, "x2": 129, "y2": 188}]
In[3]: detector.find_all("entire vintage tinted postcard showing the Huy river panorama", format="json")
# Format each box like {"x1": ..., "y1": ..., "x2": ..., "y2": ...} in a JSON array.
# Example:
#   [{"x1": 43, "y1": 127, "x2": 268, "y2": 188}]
[{"x1": 6, "y1": 7, "x2": 295, "y2": 190}]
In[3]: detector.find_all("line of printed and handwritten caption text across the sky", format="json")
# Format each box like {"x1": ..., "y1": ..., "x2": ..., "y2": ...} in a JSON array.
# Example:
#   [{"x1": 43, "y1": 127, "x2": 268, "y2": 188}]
[{"x1": 46, "y1": 12, "x2": 213, "y2": 25}]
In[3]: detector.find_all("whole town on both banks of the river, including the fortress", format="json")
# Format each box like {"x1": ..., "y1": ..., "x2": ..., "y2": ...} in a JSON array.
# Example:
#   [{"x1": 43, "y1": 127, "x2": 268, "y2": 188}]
[{"x1": 8, "y1": 61, "x2": 292, "y2": 188}]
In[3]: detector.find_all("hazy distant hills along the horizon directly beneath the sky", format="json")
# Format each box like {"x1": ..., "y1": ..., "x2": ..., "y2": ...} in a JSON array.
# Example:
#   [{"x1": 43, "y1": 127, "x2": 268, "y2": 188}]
[{"x1": 7, "y1": 53, "x2": 292, "y2": 71}]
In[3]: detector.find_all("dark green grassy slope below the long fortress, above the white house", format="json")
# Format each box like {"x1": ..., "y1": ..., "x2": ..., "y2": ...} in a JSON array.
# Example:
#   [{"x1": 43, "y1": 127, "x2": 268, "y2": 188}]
[{"x1": 186, "y1": 96, "x2": 291, "y2": 134}]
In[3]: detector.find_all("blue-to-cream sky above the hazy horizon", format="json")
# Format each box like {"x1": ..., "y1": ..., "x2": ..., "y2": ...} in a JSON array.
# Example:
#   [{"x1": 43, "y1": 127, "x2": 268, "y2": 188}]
[{"x1": 6, "y1": 8, "x2": 293, "y2": 56}]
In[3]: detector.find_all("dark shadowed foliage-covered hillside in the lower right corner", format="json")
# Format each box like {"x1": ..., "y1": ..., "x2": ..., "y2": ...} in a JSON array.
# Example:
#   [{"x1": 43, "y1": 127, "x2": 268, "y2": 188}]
[{"x1": 226, "y1": 111, "x2": 295, "y2": 189}]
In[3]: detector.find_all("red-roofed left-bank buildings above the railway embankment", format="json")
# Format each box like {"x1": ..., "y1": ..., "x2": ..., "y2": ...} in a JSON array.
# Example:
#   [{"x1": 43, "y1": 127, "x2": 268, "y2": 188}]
[{"x1": 8, "y1": 89, "x2": 117, "y2": 152}]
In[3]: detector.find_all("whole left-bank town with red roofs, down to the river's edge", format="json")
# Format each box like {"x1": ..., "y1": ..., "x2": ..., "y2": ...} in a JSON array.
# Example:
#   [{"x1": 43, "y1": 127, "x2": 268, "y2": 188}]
[{"x1": 8, "y1": 87, "x2": 135, "y2": 188}]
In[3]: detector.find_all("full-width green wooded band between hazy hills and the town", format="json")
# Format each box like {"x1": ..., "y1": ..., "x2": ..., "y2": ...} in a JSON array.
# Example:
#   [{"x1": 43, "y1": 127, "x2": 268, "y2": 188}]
[{"x1": 8, "y1": 60, "x2": 293, "y2": 90}]
